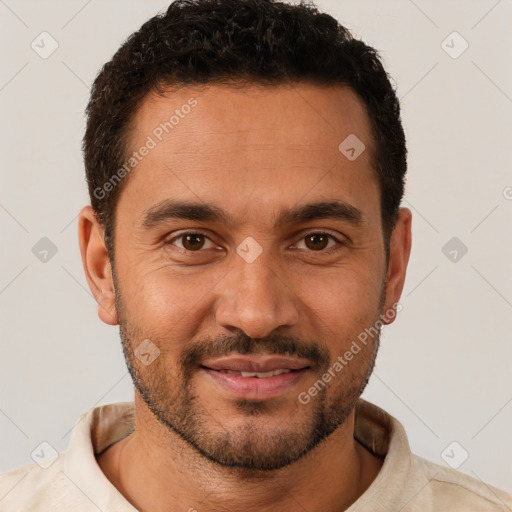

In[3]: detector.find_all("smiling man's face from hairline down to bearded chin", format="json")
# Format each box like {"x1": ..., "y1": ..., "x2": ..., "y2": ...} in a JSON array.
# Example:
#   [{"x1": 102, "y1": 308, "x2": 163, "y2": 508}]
[{"x1": 81, "y1": 84, "x2": 407, "y2": 470}]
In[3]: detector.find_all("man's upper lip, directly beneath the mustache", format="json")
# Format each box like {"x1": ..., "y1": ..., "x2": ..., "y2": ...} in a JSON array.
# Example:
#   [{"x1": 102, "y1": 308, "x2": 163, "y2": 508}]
[{"x1": 201, "y1": 355, "x2": 311, "y2": 372}]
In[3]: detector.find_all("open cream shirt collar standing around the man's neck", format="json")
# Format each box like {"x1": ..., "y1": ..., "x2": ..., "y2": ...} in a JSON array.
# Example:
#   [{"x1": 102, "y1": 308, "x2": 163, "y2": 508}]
[{"x1": 64, "y1": 399, "x2": 411, "y2": 512}]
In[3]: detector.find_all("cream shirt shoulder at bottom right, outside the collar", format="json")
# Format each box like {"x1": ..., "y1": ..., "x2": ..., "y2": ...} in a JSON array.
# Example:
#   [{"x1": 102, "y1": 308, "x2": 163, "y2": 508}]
[{"x1": 411, "y1": 455, "x2": 512, "y2": 512}]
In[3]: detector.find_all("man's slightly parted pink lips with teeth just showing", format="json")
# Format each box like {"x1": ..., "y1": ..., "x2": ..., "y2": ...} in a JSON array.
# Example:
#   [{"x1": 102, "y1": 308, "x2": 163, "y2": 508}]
[{"x1": 200, "y1": 355, "x2": 311, "y2": 401}]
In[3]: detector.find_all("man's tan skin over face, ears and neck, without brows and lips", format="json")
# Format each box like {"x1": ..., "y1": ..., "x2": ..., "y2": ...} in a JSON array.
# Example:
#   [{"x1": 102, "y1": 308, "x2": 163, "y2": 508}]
[{"x1": 79, "y1": 84, "x2": 411, "y2": 512}]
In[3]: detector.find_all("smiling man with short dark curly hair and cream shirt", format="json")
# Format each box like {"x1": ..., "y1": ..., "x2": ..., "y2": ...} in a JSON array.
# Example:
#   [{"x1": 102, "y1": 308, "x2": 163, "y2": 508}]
[{"x1": 0, "y1": 0, "x2": 512, "y2": 512}]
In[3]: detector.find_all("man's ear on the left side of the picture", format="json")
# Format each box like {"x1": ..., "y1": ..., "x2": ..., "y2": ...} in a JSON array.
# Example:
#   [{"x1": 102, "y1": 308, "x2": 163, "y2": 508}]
[{"x1": 78, "y1": 206, "x2": 119, "y2": 325}]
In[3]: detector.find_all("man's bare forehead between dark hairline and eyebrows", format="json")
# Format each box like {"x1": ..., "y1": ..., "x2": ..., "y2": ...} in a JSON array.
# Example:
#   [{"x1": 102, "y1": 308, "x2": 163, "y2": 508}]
[{"x1": 121, "y1": 83, "x2": 376, "y2": 220}]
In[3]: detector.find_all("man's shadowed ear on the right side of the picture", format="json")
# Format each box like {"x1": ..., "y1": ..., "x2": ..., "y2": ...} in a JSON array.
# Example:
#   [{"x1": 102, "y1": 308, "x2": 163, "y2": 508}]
[{"x1": 383, "y1": 208, "x2": 412, "y2": 324}]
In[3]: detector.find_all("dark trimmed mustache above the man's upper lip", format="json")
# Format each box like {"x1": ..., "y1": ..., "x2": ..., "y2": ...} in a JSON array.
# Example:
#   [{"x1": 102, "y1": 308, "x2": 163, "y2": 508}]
[{"x1": 180, "y1": 333, "x2": 330, "y2": 372}]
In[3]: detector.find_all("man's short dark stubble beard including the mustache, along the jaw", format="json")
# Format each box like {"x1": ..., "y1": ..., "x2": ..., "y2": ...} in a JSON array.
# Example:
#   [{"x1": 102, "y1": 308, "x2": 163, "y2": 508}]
[{"x1": 116, "y1": 272, "x2": 383, "y2": 472}]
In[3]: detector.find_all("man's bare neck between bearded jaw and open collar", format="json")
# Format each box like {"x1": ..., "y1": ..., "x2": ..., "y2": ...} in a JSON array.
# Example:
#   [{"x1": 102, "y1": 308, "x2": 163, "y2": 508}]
[{"x1": 98, "y1": 397, "x2": 382, "y2": 512}]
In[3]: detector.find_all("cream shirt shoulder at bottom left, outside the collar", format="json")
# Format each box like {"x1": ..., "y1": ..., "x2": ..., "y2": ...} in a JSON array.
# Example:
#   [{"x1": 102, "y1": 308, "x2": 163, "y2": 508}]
[{"x1": 0, "y1": 454, "x2": 97, "y2": 512}]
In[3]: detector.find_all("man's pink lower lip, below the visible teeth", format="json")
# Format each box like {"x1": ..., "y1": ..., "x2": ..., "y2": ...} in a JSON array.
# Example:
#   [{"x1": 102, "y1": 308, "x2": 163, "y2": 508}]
[{"x1": 200, "y1": 368, "x2": 307, "y2": 400}]
